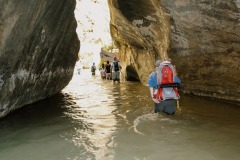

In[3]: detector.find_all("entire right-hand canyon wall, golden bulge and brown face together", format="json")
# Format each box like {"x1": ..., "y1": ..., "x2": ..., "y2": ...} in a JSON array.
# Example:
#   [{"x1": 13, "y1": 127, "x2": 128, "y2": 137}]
[{"x1": 108, "y1": 0, "x2": 240, "y2": 103}]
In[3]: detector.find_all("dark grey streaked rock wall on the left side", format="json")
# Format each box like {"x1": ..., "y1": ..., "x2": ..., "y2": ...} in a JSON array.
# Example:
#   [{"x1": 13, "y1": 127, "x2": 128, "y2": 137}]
[{"x1": 0, "y1": 0, "x2": 80, "y2": 117}]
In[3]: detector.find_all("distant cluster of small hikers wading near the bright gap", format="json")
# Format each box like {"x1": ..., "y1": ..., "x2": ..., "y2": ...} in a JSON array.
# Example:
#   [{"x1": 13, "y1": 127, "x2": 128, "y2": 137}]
[{"x1": 91, "y1": 57, "x2": 122, "y2": 82}]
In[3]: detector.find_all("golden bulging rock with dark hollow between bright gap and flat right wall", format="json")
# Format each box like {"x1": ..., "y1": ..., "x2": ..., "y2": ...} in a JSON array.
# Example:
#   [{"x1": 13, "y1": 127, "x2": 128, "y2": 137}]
[{"x1": 109, "y1": 0, "x2": 170, "y2": 83}]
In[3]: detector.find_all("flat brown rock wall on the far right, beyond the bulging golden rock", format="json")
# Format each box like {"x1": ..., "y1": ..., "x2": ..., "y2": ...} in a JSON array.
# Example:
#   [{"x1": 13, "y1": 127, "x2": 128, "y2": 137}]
[{"x1": 162, "y1": 0, "x2": 240, "y2": 103}]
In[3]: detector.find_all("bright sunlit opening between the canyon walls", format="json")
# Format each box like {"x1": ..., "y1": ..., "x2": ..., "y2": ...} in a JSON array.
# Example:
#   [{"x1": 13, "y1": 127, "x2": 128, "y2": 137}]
[{"x1": 75, "y1": 0, "x2": 115, "y2": 68}]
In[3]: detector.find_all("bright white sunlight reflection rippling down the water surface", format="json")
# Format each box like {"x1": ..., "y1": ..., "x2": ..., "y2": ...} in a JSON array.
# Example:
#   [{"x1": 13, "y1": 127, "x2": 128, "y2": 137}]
[{"x1": 63, "y1": 71, "x2": 119, "y2": 159}]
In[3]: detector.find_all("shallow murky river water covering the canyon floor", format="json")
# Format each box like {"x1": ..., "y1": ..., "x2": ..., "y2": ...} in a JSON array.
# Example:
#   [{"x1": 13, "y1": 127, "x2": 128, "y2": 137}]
[{"x1": 0, "y1": 70, "x2": 240, "y2": 160}]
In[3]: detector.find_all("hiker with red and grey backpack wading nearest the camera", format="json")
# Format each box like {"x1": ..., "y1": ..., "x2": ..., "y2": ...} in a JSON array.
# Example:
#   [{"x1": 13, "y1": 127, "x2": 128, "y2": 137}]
[{"x1": 148, "y1": 60, "x2": 181, "y2": 115}]
